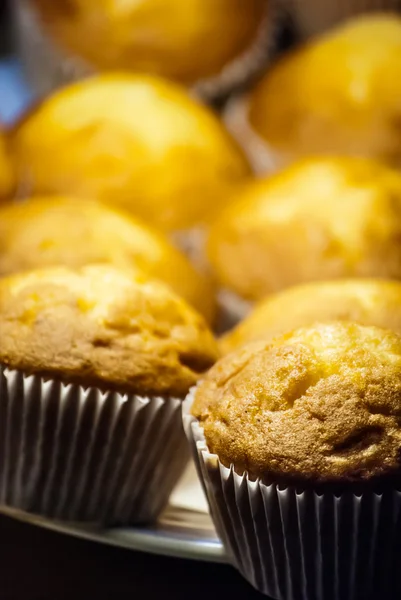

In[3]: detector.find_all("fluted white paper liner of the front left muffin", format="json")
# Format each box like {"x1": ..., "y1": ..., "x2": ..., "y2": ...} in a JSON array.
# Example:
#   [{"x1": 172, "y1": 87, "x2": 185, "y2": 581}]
[{"x1": 0, "y1": 366, "x2": 189, "y2": 524}]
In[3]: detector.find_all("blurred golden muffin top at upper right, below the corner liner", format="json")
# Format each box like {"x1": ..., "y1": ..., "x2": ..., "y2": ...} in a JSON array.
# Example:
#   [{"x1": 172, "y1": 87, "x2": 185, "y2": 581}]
[{"x1": 249, "y1": 14, "x2": 401, "y2": 165}]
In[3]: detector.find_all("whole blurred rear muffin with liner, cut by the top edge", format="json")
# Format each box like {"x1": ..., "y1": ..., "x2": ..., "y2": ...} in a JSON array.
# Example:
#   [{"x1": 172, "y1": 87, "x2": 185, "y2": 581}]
[{"x1": 14, "y1": 0, "x2": 271, "y2": 95}]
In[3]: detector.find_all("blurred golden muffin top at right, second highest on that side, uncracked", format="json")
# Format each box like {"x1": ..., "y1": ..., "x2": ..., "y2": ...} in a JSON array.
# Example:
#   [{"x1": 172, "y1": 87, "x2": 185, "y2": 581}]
[{"x1": 209, "y1": 157, "x2": 401, "y2": 300}]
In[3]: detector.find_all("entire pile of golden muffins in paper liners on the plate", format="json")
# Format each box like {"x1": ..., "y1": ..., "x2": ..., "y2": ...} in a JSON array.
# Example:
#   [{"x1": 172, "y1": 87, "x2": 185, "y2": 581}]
[{"x1": 0, "y1": 0, "x2": 401, "y2": 600}]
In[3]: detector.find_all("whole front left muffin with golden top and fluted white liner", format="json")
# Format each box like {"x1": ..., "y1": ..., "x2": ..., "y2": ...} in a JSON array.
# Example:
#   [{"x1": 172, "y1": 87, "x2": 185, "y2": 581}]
[{"x1": 0, "y1": 265, "x2": 217, "y2": 524}]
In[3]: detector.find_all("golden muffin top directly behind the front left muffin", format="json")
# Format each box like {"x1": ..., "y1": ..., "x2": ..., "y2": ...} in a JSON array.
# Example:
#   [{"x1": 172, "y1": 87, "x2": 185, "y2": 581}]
[{"x1": 0, "y1": 196, "x2": 215, "y2": 322}]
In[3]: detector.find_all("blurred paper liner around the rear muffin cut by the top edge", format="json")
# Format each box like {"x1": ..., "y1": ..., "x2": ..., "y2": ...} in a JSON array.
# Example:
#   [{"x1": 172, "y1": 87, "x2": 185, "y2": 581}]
[{"x1": 12, "y1": 0, "x2": 282, "y2": 102}]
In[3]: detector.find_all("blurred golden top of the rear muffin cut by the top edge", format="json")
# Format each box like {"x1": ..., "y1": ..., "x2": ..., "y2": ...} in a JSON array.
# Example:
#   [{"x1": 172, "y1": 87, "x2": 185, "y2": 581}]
[{"x1": 33, "y1": 0, "x2": 266, "y2": 84}]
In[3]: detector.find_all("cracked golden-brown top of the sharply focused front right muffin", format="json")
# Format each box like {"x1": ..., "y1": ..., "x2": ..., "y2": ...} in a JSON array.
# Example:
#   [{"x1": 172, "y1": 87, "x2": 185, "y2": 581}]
[{"x1": 192, "y1": 323, "x2": 401, "y2": 483}]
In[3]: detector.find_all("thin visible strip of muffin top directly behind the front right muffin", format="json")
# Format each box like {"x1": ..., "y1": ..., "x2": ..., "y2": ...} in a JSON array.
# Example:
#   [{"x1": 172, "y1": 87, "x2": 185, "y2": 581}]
[{"x1": 220, "y1": 279, "x2": 401, "y2": 354}]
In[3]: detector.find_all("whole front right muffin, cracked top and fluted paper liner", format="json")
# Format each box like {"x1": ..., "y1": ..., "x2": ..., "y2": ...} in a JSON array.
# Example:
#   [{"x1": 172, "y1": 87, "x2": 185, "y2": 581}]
[{"x1": 184, "y1": 323, "x2": 401, "y2": 600}]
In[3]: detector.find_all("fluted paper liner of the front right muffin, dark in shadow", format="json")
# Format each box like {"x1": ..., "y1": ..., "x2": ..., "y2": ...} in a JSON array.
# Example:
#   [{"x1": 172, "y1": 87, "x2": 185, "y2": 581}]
[{"x1": 183, "y1": 393, "x2": 401, "y2": 600}]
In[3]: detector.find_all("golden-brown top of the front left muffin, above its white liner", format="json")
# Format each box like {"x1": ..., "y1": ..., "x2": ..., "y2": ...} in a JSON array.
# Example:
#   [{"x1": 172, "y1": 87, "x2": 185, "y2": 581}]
[{"x1": 0, "y1": 265, "x2": 217, "y2": 397}]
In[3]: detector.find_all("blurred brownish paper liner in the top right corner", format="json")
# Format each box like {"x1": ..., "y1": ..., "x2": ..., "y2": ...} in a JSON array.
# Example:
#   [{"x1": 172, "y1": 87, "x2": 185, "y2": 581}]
[{"x1": 281, "y1": 0, "x2": 401, "y2": 40}]
